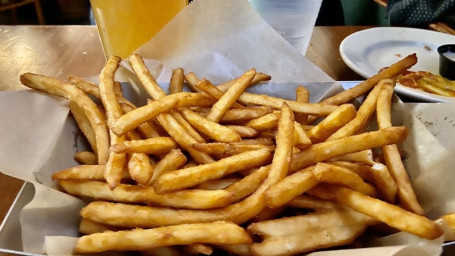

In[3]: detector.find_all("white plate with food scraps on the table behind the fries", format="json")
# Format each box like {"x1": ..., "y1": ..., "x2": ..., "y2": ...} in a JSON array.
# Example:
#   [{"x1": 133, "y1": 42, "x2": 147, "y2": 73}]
[{"x1": 339, "y1": 27, "x2": 455, "y2": 102}]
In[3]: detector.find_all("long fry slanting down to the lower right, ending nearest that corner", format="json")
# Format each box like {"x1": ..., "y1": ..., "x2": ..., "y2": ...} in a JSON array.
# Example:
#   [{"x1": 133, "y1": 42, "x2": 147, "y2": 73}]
[{"x1": 316, "y1": 184, "x2": 442, "y2": 240}]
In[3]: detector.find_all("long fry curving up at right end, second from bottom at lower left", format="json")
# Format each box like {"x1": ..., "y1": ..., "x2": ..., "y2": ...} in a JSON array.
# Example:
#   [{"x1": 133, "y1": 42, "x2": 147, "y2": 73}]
[{"x1": 81, "y1": 166, "x2": 276, "y2": 228}]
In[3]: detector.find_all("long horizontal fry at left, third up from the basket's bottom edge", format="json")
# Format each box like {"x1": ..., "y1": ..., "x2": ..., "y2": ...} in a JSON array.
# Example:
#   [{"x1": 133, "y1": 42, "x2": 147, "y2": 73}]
[{"x1": 59, "y1": 180, "x2": 234, "y2": 209}]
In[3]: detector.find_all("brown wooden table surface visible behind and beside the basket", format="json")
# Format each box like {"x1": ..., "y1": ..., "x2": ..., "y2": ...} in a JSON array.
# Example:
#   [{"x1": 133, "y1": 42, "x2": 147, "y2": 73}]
[{"x1": 0, "y1": 26, "x2": 368, "y2": 226}]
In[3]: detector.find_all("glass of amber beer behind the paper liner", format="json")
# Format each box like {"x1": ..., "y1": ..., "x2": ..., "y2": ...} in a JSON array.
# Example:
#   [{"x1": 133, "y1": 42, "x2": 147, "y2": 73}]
[{"x1": 90, "y1": 0, "x2": 188, "y2": 58}]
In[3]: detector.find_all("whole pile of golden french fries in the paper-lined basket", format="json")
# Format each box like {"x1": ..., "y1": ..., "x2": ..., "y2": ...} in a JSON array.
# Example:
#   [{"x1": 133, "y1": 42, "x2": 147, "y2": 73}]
[{"x1": 21, "y1": 54, "x2": 453, "y2": 255}]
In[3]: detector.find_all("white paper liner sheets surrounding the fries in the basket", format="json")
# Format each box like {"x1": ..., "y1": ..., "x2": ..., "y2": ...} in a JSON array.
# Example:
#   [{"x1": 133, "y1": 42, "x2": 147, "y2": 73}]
[{"x1": 0, "y1": 0, "x2": 455, "y2": 255}]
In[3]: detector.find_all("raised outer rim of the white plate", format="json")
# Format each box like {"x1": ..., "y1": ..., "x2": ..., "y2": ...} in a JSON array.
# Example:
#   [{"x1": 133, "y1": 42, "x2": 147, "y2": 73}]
[{"x1": 338, "y1": 27, "x2": 455, "y2": 102}]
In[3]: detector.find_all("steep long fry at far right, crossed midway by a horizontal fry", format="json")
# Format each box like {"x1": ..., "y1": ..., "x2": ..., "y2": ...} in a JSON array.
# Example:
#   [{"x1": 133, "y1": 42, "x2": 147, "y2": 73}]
[{"x1": 376, "y1": 81, "x2": 424, "y2": 215}]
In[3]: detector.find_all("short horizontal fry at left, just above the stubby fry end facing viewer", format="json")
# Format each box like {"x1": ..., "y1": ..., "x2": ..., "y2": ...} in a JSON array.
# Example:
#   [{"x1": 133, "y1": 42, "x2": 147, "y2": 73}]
[{"x1": 111, "y1": 137, "x2": 177, "y2": 155}]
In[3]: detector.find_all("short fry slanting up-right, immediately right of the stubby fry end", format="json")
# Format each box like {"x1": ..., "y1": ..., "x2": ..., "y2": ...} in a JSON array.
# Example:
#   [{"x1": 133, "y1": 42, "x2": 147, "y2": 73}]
[{"x1": 147, "y1": 149, "x2": 187, "y2": 184}]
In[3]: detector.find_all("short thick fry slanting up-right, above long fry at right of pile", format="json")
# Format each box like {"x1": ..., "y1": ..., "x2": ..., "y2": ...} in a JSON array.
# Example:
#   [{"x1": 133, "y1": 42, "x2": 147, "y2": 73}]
[{"x1": 308, "y1": 104, "x2": 357, "y2": 143}]
